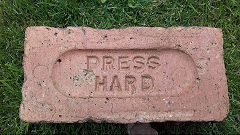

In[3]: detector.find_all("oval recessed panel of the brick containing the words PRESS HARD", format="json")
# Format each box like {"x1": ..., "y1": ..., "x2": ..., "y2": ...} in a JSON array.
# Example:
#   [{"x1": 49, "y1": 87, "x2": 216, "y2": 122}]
[{"x1": 52, "y1": 49, "x2": 197, "y2": 98}]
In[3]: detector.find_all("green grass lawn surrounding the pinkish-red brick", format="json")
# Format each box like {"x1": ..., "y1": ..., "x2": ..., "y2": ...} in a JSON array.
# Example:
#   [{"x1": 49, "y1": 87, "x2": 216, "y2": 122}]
[{"x1": 0, "y1": 0, "x2": 240, "y2": 134}]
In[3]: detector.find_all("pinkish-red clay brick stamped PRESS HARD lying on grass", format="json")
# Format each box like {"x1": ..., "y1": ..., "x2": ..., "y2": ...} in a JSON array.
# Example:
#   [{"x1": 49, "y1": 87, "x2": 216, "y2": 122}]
[{"x1": 20, "y1": 27, "x2": 229, "y2": 123}]
